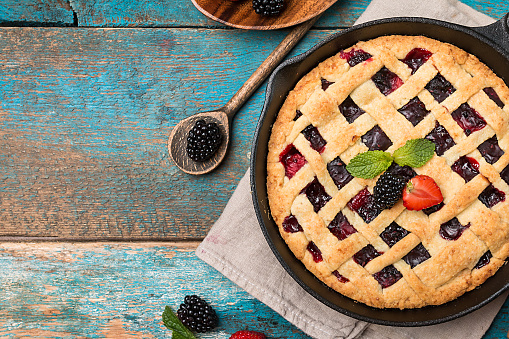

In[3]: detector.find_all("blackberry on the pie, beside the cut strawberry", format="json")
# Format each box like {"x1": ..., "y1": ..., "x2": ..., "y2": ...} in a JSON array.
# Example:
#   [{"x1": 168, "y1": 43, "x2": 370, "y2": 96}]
[{"x1": 373, "y1": 172, "x2": 407, "y2": 209}]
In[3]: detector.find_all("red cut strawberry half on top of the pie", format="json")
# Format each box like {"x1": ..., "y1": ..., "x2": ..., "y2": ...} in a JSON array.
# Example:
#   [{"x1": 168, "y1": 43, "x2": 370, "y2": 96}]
[{"x1": 403, "y1": 175, "x2": 444, "y2": 211}]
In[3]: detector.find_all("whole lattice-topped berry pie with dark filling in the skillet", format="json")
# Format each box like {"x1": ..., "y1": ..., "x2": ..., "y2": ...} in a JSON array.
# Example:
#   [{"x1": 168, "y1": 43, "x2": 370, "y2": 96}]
[{"x1": 267, "y1": 36, "x2": 509, "y2": 308}]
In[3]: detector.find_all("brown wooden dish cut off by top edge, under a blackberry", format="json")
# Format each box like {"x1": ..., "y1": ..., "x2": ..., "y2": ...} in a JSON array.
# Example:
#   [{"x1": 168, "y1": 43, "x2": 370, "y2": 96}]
[{"x1": 191, "y1": 0, "x2": 338, "y2": 30}]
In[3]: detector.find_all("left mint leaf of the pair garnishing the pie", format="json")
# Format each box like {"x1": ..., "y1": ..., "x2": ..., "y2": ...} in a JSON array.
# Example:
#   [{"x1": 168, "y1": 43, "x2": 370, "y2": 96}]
[{"x1": 346, "y1": 151, "x2": 392, "y2": 179}]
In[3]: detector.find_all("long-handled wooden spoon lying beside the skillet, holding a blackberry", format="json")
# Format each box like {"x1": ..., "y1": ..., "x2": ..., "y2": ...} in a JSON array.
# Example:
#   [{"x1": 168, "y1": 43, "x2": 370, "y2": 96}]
[{"x1": 168, "y1": 17, "x2": 318, "y2": 174}]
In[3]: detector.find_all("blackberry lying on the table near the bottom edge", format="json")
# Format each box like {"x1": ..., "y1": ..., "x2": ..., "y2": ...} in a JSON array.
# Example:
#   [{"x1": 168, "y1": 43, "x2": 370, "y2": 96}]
[{"x1": 177, "y1": 295, "x2": 218, "y2": 332}]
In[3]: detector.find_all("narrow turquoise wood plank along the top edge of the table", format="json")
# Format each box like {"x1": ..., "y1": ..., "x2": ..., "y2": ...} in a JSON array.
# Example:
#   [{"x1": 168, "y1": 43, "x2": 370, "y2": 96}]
[{"x1": 0, "y1": 0, "x2": 507, "y2": 28}]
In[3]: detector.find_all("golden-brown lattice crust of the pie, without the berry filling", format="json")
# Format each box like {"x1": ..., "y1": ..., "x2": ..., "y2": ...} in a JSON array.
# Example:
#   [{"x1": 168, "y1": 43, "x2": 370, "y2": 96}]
[{"x1": 267, "y1": 36, "x2": 509, "y2": 309}]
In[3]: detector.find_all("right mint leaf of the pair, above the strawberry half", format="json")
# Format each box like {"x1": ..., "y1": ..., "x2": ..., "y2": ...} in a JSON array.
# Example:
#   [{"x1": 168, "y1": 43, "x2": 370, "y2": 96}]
[{"x1": 393, "y1": 139, "x2": 435, "y2": 167}]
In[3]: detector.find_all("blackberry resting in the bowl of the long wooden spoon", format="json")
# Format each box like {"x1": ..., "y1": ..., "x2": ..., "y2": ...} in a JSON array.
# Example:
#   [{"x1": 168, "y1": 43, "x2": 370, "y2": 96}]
[{"x1": 186, "y1": 119, "x2": 223, "y2": 162}]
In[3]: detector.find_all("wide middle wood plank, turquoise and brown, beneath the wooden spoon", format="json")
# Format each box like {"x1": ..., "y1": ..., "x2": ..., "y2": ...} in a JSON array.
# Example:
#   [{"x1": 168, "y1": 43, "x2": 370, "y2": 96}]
[{"x1": 0, "y1": 28, "x2": 342, "y2": 239}]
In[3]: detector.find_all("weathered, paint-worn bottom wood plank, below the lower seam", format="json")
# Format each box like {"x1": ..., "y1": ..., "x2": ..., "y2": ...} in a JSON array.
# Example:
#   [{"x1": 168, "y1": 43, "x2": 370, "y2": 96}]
[{"x1": 0, "y1": 243, "x2": 309, "y2": 339}]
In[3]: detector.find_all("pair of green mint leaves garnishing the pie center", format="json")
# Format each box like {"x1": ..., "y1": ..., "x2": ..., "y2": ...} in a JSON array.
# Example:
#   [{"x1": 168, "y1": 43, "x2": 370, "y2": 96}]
[{"x1": 346, "y1": 139, "x2": 435, "y2": 179}]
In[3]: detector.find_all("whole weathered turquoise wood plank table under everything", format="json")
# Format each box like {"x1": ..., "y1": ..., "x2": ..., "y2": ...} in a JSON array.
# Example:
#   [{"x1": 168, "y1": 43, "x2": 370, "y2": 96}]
[{"x1": 0, "y1": 0, "x2": 509, "y2": 339}]
